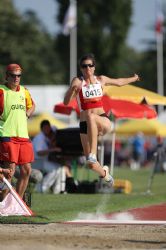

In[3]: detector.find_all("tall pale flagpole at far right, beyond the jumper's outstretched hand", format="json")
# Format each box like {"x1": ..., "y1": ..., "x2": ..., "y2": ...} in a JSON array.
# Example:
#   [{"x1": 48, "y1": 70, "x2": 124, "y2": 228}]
[{"x1": 156, "y1": 1, "x2": 164, "y2": 113}]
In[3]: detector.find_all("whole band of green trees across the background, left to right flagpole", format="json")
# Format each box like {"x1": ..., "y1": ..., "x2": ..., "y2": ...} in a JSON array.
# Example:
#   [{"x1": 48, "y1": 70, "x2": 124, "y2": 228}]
[{"x1": 0, "y1": 0, "x2": 166, "y2": 94}]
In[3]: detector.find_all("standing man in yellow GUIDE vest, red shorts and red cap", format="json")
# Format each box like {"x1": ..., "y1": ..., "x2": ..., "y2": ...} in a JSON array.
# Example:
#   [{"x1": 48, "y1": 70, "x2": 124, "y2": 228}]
[{"x1": 0, "y1": 64, "x2": 35, "y2": 201}]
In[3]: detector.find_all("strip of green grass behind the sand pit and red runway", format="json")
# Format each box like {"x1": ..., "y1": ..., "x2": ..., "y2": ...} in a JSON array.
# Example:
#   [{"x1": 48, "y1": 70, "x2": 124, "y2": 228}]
[{"x1": 0, "y1": 167, "x2": 166, "y2": 223}]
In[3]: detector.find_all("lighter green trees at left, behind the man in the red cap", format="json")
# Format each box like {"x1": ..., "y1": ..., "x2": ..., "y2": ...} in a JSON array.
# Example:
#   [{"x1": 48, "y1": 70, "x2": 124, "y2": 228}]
[{"x1": 0, "y1": 0, "x2": 60, "y2": 84}]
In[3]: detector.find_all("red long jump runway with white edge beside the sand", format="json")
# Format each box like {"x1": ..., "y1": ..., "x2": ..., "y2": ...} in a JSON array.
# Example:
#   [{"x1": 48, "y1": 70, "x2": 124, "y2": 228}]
[{"x1": 65, "y1": 203, "x2": 166, "y2": 225}]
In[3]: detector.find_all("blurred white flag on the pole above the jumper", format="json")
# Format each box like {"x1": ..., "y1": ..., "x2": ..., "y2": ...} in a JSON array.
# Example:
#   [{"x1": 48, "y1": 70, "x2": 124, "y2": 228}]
[{"x1": 62, "y1": 0, "x2": 77, "y2": 36}]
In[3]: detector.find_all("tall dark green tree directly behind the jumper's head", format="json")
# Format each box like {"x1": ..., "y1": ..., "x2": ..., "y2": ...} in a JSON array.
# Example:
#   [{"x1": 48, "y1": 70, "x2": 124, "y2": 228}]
[{"x1": 57, "y1": 0, "x2": 133, "y2": 82}]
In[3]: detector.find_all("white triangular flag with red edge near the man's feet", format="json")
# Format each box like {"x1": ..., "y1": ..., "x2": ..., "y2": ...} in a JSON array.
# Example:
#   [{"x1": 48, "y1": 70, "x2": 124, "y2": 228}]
[{"x1": 0, "y1": 178, "x2": 33, "y2": 216}]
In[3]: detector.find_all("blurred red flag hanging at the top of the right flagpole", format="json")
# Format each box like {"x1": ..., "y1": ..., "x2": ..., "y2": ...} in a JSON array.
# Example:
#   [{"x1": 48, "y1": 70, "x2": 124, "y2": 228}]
[{"x1": 155, "y1": 0, "x2": 164, "y2": 36}]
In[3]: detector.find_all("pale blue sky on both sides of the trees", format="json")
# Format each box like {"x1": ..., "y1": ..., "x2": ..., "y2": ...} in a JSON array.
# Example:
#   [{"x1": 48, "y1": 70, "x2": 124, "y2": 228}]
[{"x1": 13, "y1": 0, "x2": 158, "y2": 51}]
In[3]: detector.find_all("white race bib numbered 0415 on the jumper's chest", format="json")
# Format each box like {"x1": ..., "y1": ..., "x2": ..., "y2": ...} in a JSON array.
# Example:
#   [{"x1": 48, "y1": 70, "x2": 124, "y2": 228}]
[{"x1": 82, "y1": 83, "x2": 103, "y2": 102}]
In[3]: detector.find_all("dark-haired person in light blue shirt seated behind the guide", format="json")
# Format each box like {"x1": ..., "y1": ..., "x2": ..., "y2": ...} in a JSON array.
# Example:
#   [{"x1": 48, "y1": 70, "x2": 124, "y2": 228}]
[{"x1": 32, "y1": 120, "x2": 66, "y2": 194}]
